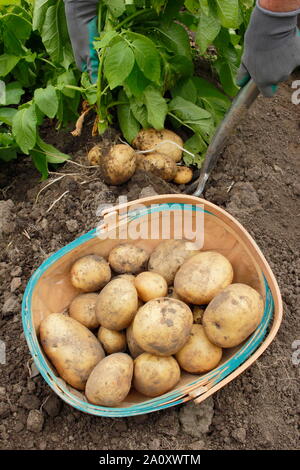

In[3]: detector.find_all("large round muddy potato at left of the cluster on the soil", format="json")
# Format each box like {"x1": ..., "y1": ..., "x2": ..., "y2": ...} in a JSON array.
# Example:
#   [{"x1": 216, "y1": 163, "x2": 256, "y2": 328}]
[{"x1": 100, "y1": 144, "x2": 136, "y2": 186}]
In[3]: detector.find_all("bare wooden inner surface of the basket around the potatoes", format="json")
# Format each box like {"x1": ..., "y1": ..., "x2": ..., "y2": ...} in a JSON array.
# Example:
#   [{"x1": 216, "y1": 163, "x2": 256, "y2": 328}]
[{"x1": 30, "y1": 205, "x2": 266, "y2": 414}]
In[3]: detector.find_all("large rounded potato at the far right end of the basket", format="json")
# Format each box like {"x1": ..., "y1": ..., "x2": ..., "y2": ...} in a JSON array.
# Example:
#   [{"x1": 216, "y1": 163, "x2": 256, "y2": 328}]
[{"x1": 203, "y1": 284, "x2": 264, "y2": 348}]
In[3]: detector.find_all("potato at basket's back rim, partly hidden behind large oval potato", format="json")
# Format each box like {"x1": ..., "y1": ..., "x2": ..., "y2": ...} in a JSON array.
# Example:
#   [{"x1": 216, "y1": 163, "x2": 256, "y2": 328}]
[{"x1": 148, "y1": 240, "x2": 199, "y2": 286}]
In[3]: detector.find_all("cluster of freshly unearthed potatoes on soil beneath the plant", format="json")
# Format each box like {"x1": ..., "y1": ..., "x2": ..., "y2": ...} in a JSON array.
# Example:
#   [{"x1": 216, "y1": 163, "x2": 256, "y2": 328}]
[{"x1": 87, "y1": 129, "x2": 193, "y2": 186}]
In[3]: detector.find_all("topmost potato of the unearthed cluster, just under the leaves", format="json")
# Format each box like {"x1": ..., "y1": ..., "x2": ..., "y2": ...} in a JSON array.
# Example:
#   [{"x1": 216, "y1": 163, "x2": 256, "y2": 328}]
[{"x1": 132, "y1": 129, "x2": 184, "y2": 163}]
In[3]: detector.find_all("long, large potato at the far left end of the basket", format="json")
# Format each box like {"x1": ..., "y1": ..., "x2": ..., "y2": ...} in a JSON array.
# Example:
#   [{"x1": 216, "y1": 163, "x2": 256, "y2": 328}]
[{"x1": 40, "y1": 313, "x2": 105, "y2": 390}]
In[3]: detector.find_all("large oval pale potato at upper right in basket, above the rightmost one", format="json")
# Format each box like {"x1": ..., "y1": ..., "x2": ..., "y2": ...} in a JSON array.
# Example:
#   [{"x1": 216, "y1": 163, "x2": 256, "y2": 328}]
[{"x1": 174, "y1": 251, "x2": 233, "y2": 305}]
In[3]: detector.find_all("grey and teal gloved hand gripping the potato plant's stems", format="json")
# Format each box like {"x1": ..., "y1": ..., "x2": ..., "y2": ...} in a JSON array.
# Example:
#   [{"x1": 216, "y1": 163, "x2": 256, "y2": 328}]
[{"x1": 64, "y1": 0, "x2": 99, "y2": 83}]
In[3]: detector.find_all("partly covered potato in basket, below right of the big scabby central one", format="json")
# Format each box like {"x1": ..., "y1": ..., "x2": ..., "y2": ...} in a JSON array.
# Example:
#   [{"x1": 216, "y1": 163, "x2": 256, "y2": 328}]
[{"x1": 175, "y1": 325, "x2": 222, "y2": 374}]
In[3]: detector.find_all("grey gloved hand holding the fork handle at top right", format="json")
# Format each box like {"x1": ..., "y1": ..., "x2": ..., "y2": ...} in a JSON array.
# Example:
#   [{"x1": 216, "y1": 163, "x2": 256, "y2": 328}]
[{"x1": 237, "y1": 1, "x2": 300, "y2": 97}]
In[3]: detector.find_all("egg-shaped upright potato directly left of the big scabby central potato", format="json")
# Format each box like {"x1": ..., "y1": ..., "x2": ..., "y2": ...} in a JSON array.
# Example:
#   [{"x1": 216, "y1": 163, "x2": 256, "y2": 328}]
[{"x1": 96, "y1": 279, "x2": 138, "y2": 331}]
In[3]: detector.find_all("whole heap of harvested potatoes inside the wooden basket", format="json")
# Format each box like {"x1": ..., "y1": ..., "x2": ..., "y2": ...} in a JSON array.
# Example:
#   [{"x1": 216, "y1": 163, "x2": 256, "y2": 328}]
[{"x1": 39, "y1": 240, "x2": 264, "y2": 407}]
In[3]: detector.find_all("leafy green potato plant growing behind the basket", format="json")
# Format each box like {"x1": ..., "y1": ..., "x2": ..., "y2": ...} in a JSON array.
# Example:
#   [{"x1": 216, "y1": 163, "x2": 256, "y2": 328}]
[{"x1": 0, "y1": 0, "x2": 254, "y2": 178}]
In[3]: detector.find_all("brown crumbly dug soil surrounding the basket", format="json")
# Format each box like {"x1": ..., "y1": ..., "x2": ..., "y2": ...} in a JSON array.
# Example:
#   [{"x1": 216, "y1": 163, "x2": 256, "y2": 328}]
[{"x1": 0, "y1": 81, "x2": 300, "y2": 450}]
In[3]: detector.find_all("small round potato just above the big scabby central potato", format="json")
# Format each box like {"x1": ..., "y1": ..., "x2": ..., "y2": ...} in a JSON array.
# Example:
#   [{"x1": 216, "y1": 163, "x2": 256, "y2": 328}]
[{"x1": 134, "y1": 271, "x2": 168, "y2": 302}]
